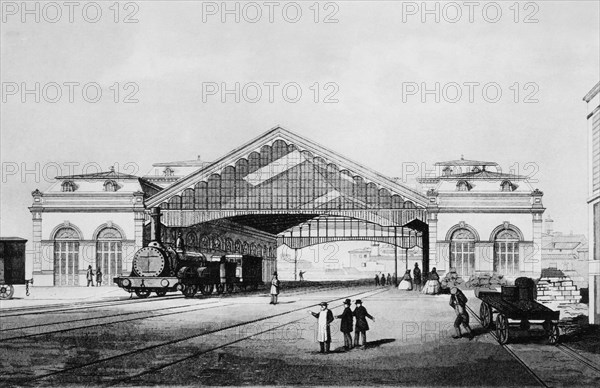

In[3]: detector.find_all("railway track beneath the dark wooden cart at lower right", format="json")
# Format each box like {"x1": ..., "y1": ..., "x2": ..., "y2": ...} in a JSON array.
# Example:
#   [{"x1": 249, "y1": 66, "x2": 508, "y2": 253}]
[{"x1": 466, "y1": 305, "x2": 600, "y2": 387}]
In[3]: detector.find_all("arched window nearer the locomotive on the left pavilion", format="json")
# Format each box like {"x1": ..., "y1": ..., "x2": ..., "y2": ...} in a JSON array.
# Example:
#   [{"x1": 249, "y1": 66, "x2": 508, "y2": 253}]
[{"x1": 94, "y1": 228, "x2": 123, "y2": 286}]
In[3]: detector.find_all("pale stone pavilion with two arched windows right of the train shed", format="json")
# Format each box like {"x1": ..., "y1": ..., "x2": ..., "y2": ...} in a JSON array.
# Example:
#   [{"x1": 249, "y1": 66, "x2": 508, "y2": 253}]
[{"x1": 419, "y1": 157, "x2": 545, "y2": 278}]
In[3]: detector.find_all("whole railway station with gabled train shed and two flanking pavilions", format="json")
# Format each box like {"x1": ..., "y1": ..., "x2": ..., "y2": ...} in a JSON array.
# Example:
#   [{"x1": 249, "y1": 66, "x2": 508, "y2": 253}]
[{"x1": 30, "y1": 127, "x2": 545, "y2": 285}]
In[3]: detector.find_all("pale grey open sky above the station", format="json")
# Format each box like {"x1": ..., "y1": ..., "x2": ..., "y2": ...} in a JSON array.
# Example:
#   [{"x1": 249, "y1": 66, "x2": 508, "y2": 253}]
[{"x1": 0, "y1": 1, "x2": 600, "y2": 246}]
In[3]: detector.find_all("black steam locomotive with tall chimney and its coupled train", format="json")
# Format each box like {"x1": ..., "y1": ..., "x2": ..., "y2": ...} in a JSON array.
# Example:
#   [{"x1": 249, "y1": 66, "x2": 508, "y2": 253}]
[{"x1": 113, "y1": 209, "x2": 263, "y2": 298}]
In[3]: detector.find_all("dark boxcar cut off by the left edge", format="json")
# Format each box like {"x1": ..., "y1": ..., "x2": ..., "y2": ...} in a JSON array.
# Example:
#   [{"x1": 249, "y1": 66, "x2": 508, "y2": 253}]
[{"x1": 0, "y1": 237, "x2": 27, "y2": 299}]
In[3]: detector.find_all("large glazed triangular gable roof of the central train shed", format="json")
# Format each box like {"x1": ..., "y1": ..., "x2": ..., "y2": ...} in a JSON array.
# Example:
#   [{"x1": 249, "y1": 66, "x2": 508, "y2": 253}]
[{"x1": 146, "y1": 127, "x2": 427, "y2": 247}]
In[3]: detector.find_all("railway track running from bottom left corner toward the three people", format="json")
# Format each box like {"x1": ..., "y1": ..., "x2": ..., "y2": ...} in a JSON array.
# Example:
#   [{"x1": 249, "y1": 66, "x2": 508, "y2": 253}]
[{"x1": 8, "y1": 288, "x2": 388, "y2": 386}]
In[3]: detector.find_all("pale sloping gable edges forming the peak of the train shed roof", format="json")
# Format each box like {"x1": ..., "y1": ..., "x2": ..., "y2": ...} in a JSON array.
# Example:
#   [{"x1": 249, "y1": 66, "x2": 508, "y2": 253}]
[{"x1": 147, "y1": 126, "x2": 427, "y2": 207}]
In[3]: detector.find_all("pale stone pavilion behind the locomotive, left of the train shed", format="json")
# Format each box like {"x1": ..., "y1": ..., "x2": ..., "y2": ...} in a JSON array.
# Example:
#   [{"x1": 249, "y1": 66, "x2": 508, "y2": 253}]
[{"x1": 29, "y1": 168, "x2": 160, "y2": 286}]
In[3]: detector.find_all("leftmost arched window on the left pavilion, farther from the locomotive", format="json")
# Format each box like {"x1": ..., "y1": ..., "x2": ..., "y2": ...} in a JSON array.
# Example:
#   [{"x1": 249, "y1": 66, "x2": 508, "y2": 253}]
[{"x1": 54, "y1": 227, "x2": 79, "y2": 286}]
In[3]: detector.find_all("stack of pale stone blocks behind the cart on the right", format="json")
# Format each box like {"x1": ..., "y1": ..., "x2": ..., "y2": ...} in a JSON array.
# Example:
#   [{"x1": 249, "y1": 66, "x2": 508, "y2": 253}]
[{"x1": 537, "y1": 268, "x2": 581, "y2": 304}]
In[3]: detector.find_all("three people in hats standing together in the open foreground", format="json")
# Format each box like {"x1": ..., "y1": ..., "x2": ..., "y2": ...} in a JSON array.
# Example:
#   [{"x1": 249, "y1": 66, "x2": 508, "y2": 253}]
[{"x1": 309, "y1": 299, "x2": 375, "y2": 353}]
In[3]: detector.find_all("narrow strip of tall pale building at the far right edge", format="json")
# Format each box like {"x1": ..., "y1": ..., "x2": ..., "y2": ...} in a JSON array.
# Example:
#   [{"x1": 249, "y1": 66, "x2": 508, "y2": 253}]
[{"x1": 583, "y1": 82, "x2": 600, "y2": 324}]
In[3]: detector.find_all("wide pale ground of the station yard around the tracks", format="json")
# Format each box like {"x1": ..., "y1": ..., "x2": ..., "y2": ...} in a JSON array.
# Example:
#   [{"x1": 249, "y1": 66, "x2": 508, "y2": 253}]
[{"x1": 0, "y1": 287, "x2": 600, "y2": 387}]
